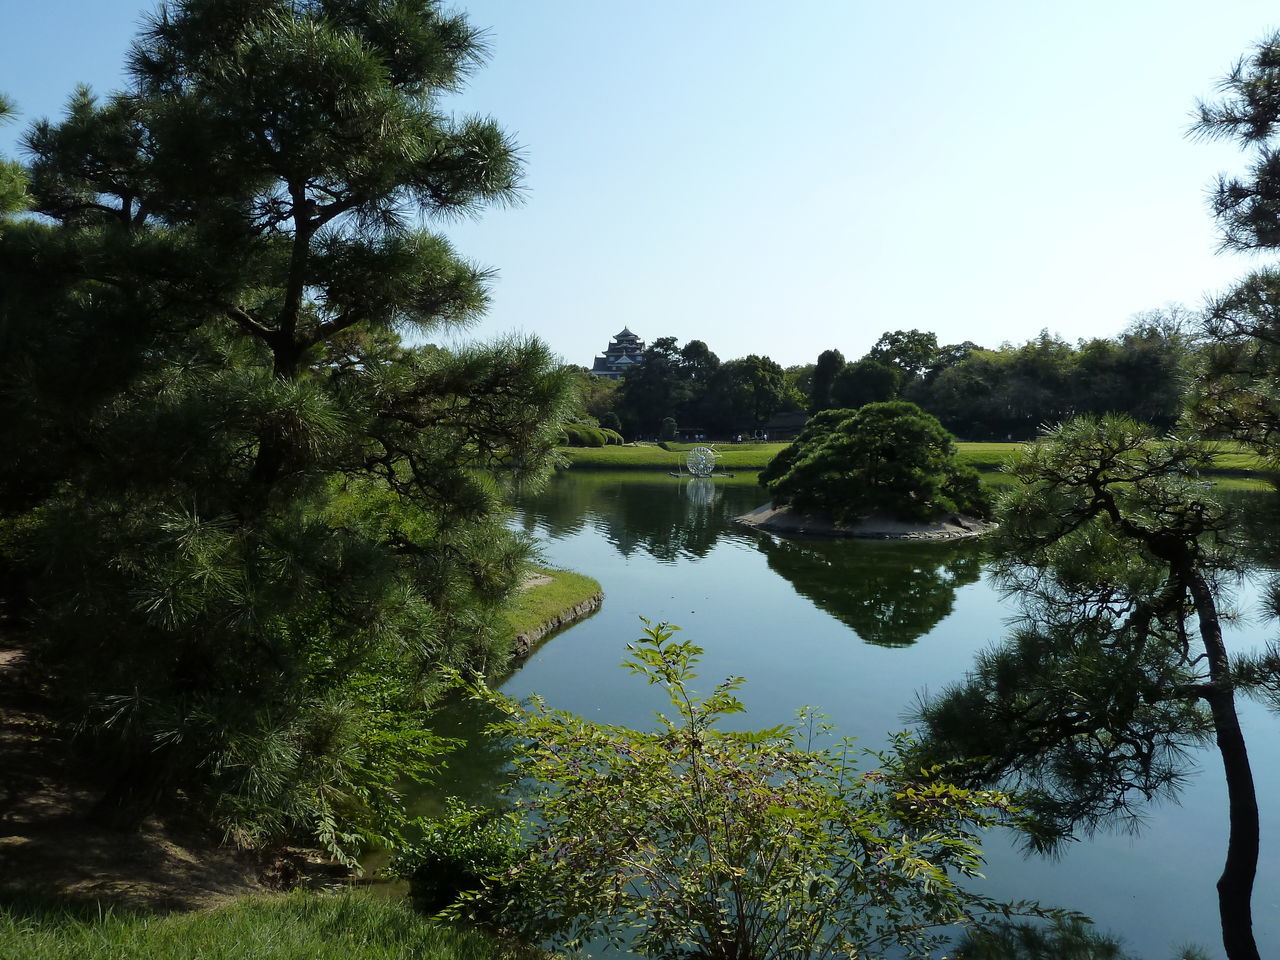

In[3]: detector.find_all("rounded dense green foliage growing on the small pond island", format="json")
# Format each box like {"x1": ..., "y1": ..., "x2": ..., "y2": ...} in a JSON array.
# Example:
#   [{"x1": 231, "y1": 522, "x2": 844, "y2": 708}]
[{"x1": 760, "y1": 401, "x2": 991, "y2": 522}]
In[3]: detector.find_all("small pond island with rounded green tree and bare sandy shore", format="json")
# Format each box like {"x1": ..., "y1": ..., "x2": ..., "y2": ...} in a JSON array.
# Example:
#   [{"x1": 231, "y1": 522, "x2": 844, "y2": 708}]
[{"x1": 737, "y1": 401, "x2": 993, "y2": 540}]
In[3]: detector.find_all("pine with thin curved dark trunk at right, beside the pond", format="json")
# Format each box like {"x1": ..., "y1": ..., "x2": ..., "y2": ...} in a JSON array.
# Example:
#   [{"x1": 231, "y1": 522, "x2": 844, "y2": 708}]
[{"x1": 919, "y1": 417, "x2": 1266, "y2": 960}]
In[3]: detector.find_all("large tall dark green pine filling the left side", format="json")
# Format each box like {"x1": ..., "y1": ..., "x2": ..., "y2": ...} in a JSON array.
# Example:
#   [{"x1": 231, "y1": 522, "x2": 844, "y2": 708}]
[{"x1": 0, "y1": 0, "x2": 570, "y2": 856}]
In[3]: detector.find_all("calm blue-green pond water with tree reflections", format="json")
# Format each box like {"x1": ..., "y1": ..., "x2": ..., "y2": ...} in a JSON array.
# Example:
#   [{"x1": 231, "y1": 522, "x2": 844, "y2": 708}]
[{"x1": 440, "y1": 472, "x2": 1280, "y2": 960}]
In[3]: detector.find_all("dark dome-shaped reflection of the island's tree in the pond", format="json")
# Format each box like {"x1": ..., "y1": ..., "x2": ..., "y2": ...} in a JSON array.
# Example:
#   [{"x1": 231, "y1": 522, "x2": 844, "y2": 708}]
[{"x1": 760, "y1": 538, "x2": 982, "y2": 646}]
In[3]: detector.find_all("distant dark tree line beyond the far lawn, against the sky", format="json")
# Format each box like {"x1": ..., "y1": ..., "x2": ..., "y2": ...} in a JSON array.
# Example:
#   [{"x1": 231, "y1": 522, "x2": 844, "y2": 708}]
[{"x1": 581, "y1": 306, "x2": 1199, "y2": 440}]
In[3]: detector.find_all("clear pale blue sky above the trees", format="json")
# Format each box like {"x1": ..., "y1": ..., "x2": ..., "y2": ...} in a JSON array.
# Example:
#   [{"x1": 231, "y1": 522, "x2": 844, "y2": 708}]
[{"x1": 0, "y1": 0, "x2": 1280, "y2": 365}]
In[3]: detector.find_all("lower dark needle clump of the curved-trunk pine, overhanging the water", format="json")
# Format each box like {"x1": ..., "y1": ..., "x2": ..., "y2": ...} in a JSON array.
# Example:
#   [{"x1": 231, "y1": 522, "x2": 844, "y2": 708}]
[{"x1": 920, "y1": 586, "x2": 1211, "y2": 849}]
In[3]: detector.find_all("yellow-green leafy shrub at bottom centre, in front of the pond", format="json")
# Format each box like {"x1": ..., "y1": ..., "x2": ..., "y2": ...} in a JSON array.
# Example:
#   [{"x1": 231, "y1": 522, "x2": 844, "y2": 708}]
[{"x1": 454, "y1": 625, "x2": 1057, "y2": 960}]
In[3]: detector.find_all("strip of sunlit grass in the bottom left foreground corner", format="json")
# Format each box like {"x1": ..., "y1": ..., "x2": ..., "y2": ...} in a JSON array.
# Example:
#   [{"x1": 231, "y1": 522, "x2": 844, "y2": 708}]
[{"x1": 0, "y1": 892, "x2": 534, "y2": 960}]
